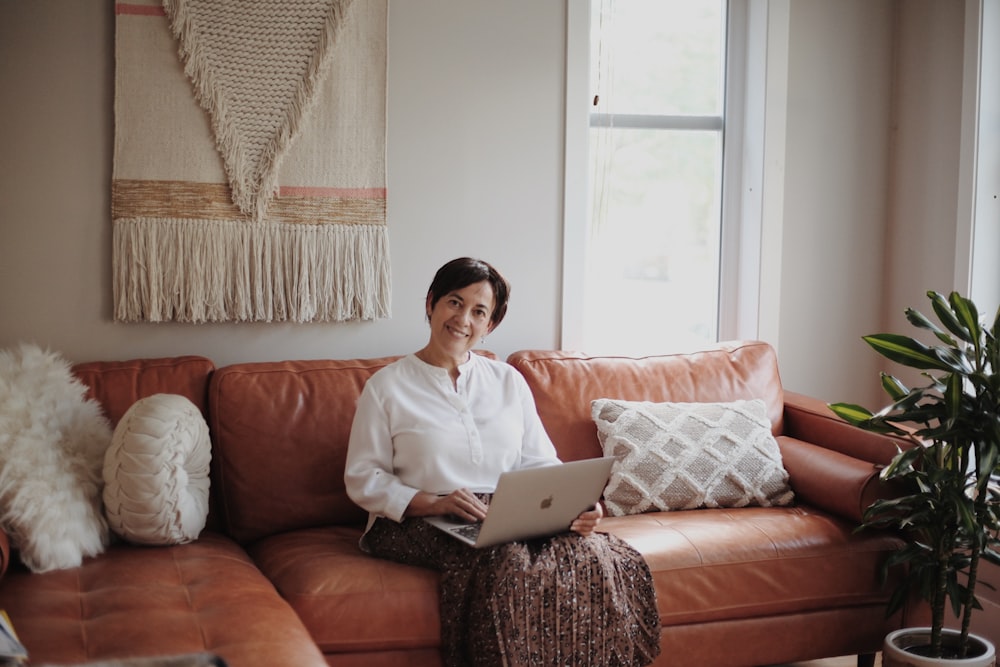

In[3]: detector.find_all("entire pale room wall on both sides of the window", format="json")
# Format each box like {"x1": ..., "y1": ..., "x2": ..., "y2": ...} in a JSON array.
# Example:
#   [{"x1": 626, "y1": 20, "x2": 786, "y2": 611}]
[{"x1": 0, "y1": 0, "x2": 980, "y2": 412}]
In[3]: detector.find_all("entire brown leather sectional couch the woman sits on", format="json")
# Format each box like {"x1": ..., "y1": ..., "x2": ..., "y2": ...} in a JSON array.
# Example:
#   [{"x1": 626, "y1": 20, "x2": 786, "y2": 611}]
[{"x1": 0, "y1": 342, "x2": 920, "y2": 667}]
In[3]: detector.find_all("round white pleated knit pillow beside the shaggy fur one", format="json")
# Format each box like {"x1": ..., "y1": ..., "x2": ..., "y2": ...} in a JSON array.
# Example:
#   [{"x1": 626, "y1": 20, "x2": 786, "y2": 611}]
[{"x1": 104, "y1": 394, "x2": 212, "y2": 545}]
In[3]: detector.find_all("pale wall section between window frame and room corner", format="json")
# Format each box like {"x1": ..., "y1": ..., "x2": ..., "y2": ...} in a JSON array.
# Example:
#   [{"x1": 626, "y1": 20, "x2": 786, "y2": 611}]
[{"x1": 765, "y1": 0, "x2": 893, "y2": 402}]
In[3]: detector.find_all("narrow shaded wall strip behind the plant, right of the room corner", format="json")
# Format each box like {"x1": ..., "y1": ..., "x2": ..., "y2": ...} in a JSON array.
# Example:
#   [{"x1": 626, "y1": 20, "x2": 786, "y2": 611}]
[{"x1": 882, "y1": 0, "x2": 969, "y2": 332}]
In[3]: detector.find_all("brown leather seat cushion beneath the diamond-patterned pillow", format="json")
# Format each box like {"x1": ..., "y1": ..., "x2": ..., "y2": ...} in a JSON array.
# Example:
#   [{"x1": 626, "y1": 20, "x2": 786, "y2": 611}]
[{"x1": 601, "y1": 506, "x2": 901, "y2": 625}]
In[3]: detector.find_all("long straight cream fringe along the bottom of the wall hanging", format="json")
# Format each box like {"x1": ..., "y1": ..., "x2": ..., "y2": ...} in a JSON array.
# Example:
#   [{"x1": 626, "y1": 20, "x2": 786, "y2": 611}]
[{"x1": 113, "y1": 218, "x2": 390, "y2": 323}]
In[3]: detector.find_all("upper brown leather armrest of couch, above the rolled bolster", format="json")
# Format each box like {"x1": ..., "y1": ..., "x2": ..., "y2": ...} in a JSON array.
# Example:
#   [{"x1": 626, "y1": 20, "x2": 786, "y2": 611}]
[{"x1": 782, "y1": 391, "x2": 913, "y2": 466}]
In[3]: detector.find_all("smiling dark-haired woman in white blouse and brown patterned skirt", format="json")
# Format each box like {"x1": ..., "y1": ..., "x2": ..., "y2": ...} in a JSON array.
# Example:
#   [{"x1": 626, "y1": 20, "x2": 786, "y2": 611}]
[{"x1": 344, "y1": 257, "x2": 660, "y2": 667}]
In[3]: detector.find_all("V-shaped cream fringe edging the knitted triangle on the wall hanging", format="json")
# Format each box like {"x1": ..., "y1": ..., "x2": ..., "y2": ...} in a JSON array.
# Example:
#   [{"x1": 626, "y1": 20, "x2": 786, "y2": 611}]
[{"x1": 163, "y1": 0, "x2": 352, "y2": 221}]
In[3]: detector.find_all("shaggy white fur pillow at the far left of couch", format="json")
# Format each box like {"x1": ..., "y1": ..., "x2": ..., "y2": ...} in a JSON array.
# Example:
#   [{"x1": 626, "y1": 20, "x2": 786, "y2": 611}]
[{"x1": 0, "y1": 344, "x2": 111, "y2": 572}]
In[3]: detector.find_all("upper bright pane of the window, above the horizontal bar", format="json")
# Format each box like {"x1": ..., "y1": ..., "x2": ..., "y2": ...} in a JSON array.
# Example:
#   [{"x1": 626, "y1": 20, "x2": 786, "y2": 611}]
[{"x1": 591, "y1": 0, "x2": 725, "y2": 116}]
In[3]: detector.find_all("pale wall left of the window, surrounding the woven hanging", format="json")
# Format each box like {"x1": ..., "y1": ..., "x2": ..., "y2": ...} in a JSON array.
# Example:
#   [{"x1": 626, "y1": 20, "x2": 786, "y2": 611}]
[{"x1": 0, "y1": 0, "x2": 565, "y2": 365}]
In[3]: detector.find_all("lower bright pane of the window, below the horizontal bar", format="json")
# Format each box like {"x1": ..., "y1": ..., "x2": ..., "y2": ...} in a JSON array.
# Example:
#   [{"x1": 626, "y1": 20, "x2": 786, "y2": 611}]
[{"x1": 584, "y1": 128, "x2": 722, "y2": 354}]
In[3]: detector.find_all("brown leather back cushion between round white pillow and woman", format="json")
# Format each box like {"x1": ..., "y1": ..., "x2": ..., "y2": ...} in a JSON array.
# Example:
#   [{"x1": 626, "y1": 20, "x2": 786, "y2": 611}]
[{"x1": 209, "y1": 357, "x2": 398, "y2": 544}]
